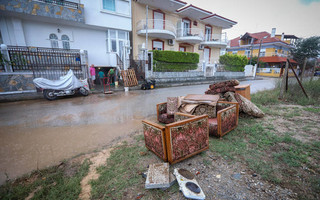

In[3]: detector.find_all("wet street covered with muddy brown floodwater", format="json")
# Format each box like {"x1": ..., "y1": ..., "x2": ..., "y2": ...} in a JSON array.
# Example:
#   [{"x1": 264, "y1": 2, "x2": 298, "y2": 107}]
[{"x1": 0, "y1": 79, "x2": 276, "y2": 184}]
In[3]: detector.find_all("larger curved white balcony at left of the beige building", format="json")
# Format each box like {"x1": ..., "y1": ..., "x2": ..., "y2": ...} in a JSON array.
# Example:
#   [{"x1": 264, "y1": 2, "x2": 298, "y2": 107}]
[{"x1": 136, "y1": 19, "x2": 176, "y2": 39}]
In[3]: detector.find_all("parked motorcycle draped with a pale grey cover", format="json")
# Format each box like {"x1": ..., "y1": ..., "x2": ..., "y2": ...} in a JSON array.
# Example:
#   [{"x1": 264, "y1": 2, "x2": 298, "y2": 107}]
[{"x1": 33, "y1": 69, "x2": 89, "y2": 101}]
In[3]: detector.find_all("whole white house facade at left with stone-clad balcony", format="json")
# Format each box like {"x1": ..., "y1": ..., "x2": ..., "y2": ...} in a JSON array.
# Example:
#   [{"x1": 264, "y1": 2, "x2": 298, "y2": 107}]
[{"x1": 0, "y1": 0, "x2": 132, "y2": 66}]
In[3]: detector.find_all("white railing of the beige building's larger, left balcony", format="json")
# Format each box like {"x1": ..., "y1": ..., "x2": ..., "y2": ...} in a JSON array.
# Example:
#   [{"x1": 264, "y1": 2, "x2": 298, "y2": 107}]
[{"x1": 137, "y1": 19, "x2": 176, "y2": 35}]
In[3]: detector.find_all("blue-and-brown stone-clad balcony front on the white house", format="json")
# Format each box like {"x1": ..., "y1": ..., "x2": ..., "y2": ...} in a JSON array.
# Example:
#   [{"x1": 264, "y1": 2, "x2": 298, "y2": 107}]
[{"x1": 1, "y1": 0, "x2": 84, "y2": 23}]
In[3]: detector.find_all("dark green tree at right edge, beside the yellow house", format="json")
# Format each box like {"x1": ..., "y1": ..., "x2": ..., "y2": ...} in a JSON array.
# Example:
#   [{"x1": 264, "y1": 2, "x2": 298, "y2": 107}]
[{"x1": 291, "y1": 36, "x2": 320, "y2": 65}]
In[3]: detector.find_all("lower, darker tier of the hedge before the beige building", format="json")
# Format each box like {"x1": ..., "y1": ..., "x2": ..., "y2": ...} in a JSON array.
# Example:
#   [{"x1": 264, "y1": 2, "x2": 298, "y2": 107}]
[{"x1": 153, "y1": 60, "x2": 198, "y2": 72}]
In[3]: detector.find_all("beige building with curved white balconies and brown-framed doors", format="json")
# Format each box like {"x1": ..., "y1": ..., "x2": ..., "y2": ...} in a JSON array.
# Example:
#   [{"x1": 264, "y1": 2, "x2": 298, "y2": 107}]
[{"x1": 132, "y1": 0, "x2": 237, "y2": 66}]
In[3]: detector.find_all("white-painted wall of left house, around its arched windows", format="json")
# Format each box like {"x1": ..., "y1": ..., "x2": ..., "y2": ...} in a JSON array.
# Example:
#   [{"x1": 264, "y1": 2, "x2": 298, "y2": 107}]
[{"x1": 0, "y1": 0, "x2": 132, "y2": 66}]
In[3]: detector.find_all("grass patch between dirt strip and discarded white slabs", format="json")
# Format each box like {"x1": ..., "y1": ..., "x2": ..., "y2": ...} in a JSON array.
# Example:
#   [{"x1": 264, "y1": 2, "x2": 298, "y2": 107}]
[{"x1": 91, "y1": 142, "x2": 179, "y2": 199}]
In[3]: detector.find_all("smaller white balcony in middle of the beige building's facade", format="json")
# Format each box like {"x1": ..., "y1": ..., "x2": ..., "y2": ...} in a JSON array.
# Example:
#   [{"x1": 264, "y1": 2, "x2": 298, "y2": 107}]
[{"x1": 176, "y1": 28, "x2": 204, "y2": 44}]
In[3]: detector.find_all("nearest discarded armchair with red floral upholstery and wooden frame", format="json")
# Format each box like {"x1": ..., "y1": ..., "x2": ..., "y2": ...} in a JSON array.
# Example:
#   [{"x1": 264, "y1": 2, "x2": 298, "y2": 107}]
[{"x1": 142, "y1": 112, "x2": 209, "y2": 164}]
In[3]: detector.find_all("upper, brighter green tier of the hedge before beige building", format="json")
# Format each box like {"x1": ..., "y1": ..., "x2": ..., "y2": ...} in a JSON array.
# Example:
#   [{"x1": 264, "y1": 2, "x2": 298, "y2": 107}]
[{"x1": 152, "y1": 50, "x2": 199, "y2": 64}]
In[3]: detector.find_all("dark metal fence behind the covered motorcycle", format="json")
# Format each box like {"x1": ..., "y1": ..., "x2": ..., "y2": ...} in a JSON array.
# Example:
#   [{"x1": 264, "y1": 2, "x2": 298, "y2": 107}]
[{"x1": 8, "y1": 46, "x2": 86, "y2": 80}]
